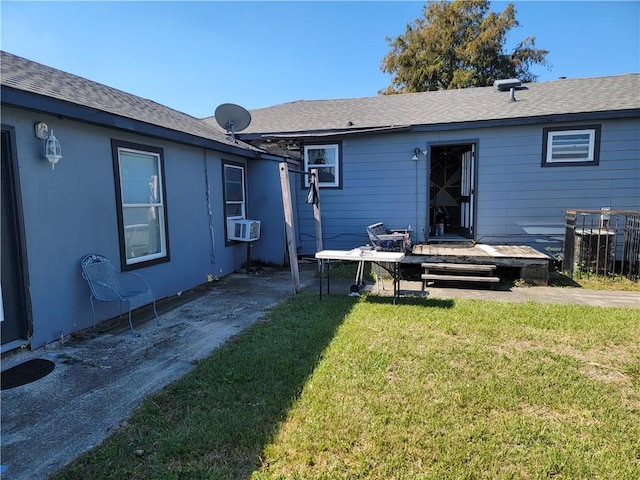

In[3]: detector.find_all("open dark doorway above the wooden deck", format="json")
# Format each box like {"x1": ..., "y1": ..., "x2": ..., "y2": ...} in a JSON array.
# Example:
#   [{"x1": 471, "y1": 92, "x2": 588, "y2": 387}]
[{"x1": 429, "y1": 143, "x2": 475, "y2": 239}]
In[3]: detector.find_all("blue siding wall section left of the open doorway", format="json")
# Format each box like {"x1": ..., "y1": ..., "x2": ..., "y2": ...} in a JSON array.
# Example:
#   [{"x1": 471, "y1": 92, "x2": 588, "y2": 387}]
[{"x1": 296, "y1": 131, "x2": 427, "y2": 254}]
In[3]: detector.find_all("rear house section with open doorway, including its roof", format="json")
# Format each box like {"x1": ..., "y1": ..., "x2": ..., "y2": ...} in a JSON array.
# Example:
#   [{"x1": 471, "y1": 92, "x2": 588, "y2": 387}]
[{"x1": 230, "y1": 73, "x2": 640, "y2": 254}]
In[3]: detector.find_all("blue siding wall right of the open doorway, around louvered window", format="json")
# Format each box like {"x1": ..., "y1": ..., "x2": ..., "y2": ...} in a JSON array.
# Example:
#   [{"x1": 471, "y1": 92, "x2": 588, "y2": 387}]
[{"x1": 476, "y1": 120, "x2": 640, "y2": 250}]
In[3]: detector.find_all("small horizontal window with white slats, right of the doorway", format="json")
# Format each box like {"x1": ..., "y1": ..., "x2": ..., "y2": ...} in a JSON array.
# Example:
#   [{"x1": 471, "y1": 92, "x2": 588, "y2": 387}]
[{"x1": 542, "y1": 125, "x2": 600, "y2": 167}]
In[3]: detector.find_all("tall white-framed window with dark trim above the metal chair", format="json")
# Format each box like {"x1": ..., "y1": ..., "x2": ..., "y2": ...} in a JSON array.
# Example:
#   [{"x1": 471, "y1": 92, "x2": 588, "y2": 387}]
[{"x1": 112, "y1": 140, "x2": 169, "y2": 270}]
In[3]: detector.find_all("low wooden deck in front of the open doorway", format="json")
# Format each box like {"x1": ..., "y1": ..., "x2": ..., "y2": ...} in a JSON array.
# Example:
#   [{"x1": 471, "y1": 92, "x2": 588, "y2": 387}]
[{"x1": 402, "y1": 243, "x2": 551, "y2": 285}]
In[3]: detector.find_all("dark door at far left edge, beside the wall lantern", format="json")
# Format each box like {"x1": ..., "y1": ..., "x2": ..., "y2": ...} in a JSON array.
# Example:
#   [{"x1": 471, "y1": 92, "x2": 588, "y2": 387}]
[{"x1": 0, "y1": 129, "x2": 27, "y2": 345}]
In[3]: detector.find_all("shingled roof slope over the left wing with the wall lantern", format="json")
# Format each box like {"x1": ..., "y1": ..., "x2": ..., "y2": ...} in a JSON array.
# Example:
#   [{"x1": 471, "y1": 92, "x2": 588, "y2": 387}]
[{"x1": 0, "y1": 51, "x2": 255, "y2": 150}]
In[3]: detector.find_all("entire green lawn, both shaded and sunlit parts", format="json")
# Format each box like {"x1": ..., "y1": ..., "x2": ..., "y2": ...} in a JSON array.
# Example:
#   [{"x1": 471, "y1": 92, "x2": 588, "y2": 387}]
[{"x1": 54, "y1": 294, "x2": 640, "y2": 480}]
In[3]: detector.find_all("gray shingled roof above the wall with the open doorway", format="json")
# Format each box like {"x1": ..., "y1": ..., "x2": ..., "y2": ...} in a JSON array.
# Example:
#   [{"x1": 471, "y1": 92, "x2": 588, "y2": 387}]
[{"x1": 218, "y1": 73, "x2": 640, "y2": 139}]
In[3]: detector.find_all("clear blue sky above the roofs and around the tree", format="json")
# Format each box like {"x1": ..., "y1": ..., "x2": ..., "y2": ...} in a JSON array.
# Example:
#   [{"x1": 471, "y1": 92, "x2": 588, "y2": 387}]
[{"x1": 0, "y1": 0, "x2": 640, "y2": 118}]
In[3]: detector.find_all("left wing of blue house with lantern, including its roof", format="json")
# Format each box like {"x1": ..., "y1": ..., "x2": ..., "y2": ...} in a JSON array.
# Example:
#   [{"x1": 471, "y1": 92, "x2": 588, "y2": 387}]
[{"x1": 0, "y1": 52, "x2": 286, "y2": 352}]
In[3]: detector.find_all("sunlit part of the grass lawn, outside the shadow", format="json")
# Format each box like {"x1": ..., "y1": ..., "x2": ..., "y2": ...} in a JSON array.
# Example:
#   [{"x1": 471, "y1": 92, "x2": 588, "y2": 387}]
[{"x1": 255, "y1": 301, "x2": 640, "y2": 479}]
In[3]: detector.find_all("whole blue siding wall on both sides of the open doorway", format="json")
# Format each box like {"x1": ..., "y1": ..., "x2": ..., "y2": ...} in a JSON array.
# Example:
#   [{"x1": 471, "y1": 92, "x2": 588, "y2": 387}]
[{"x1": 296, "y1": 119, "x2": 640, "y2": 254}]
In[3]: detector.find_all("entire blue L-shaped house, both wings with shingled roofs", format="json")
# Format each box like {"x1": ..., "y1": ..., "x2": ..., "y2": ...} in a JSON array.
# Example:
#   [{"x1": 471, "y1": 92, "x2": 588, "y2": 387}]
[{"x1": 0, "y1": 52, "x2": 640, "y2": 352}]
